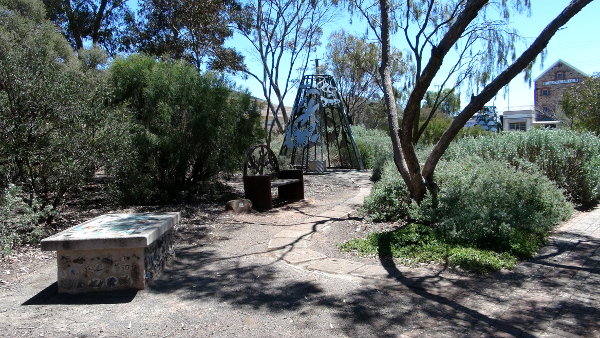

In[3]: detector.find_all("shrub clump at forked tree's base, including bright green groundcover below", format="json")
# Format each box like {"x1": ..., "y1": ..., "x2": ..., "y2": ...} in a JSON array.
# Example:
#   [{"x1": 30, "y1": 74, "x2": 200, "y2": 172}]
[{"x1": 356, "y1": 156, "x2": 572, "y2": 272}]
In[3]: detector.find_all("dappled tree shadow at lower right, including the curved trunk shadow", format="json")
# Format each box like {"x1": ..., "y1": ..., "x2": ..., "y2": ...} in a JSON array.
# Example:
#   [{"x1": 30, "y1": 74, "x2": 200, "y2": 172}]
[{"x1": 330, "y1": 228, "x2": 600, "y2": 337}]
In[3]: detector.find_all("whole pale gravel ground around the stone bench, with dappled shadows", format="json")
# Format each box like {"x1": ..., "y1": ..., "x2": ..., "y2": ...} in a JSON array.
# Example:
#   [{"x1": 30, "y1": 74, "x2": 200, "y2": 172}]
[{"x1": 0, "y1": 171, "x2": 600, "y2": 337}]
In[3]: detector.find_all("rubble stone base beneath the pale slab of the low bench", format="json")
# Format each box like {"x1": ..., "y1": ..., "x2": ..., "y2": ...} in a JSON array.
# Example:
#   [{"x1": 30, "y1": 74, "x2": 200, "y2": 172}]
[{"x1": 57, "y1": 230, "x2": 174, "y2": 294}]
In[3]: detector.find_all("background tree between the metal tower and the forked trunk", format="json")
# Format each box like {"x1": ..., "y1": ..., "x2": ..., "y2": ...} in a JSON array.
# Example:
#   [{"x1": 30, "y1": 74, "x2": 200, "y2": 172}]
[{"x1": 326, "y1": 30, "x2": 408, "y2": 124}]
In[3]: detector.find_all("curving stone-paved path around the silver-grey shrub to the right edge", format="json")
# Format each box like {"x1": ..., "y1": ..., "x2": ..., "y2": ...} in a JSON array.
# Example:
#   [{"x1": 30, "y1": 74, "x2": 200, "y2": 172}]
[{"x1": 268, "y1": 172, "x2": 600, "y2": 337}]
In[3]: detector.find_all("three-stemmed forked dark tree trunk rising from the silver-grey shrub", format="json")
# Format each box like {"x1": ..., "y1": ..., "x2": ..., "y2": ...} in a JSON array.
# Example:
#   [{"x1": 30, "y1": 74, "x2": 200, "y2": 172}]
[{"x1": 379, "y1": 0, "x2": 593, "y2": 203}]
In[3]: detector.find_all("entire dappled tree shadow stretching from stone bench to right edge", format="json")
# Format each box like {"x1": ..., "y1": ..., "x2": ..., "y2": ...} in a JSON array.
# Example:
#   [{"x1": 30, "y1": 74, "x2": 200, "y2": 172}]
[{"x1": 139, "y1": 197, "x2": 600, "y2": 337}]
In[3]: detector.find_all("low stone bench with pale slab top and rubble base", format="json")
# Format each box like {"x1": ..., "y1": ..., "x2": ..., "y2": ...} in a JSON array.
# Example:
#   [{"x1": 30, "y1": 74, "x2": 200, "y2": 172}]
[{"x1": 42, "y1": 212, "x2": 181, "y2": 293}]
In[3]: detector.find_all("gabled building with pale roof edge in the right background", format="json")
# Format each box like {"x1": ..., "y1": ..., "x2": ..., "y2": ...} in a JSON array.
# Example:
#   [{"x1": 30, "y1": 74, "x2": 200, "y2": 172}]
[{"x1": 532, "y1": 59, "x2": 588, "y2": 115}]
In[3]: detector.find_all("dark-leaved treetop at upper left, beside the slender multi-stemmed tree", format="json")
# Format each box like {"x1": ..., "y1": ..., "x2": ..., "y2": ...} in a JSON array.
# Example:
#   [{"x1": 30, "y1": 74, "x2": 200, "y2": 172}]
[{"x1": 129, "y1": 0, "x2": 242, "y2": 70}]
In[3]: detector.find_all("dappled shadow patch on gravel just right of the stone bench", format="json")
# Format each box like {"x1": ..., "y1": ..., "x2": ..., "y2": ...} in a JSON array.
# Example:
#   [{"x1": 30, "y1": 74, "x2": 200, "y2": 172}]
[{"x1": 150, "y1": 248, "x2": 332, "y2": 312}]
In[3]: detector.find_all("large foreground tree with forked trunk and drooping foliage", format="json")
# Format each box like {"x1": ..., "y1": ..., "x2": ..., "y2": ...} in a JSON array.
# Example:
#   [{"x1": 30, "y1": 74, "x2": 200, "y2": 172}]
[{"x1": 351, "y1": 0, "x2": 592, "y2": 202}]
